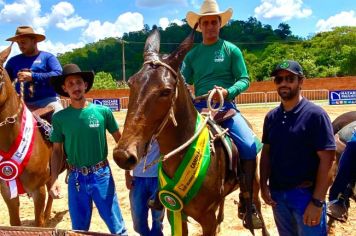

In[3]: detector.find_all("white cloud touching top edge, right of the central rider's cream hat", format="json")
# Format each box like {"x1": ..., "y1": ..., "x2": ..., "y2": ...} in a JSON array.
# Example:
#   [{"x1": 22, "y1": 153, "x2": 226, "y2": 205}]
[{"x1": 255, "y1": 0, "x2": 313, "y2": 21}]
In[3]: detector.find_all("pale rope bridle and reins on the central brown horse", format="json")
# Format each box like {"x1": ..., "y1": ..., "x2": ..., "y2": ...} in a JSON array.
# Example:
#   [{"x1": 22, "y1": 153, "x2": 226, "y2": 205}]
[{"x1": 143, "y1": 60, "x2": 224, "y2": 171}]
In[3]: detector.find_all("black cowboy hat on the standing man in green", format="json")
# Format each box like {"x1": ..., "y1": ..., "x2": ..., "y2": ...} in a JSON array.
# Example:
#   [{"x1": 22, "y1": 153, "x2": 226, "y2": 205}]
[{"x1": 50, "y1": 64, "x2": 94, "y2": 97}]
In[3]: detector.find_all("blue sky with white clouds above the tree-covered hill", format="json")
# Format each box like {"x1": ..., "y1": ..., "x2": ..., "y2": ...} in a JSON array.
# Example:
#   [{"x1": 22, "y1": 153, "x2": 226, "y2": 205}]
[{"x1": 0, "y1": 0, "x2": 356, "y2": 55}]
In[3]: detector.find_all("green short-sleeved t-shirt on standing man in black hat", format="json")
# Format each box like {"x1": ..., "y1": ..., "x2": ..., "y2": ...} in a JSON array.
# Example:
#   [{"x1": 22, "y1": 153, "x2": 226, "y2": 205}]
[{"x1": 50, "y1": 103, "x2": 119, "y2": 167}]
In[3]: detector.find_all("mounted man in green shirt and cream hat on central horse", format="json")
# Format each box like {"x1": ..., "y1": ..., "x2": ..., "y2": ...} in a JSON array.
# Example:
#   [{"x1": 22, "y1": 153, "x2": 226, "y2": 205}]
[{"x1": 181, "y1": 0, "x2": 260, "y2": 230}]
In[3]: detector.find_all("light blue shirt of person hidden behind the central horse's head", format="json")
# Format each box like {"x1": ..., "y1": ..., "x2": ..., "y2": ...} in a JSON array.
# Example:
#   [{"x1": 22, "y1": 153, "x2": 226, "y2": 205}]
[{"x1": 133, "y1": 140, "x2": 160, "y2": 177}]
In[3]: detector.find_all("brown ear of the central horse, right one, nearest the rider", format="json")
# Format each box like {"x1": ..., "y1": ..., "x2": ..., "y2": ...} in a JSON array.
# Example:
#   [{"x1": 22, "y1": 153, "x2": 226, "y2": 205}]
[{"x1": 165, "y1": 23, "x2": 198, "y2": 70}]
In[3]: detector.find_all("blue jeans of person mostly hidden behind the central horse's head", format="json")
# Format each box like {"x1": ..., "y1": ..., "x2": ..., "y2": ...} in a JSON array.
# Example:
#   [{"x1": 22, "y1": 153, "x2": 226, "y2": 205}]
[{"x1": 130, "y1": 176, "x2": 164, "y2": 236}]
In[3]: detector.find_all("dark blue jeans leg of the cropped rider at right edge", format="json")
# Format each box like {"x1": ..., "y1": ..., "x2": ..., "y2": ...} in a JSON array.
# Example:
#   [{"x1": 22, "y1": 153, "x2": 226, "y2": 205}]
[{"x1": 329, "y1": 140, "x2": 356, "y2": 201}]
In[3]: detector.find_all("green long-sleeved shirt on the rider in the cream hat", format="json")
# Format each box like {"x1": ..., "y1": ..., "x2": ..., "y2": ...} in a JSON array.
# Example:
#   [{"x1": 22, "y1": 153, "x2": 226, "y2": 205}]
[{"x1": 181, "y1": 39, "x2": 250, "y2": 100}]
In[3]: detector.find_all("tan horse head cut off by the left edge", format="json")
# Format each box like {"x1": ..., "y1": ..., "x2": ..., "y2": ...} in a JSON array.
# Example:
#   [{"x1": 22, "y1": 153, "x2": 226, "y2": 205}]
[{"x1": 0, "y1": 44, "x2": 15, "y2": 107}]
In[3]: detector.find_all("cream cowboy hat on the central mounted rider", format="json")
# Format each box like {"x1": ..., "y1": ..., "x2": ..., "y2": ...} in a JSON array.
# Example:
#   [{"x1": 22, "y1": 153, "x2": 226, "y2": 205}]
[{"x1": 186, "y1": 0, "x2": 232, "y2": 31}]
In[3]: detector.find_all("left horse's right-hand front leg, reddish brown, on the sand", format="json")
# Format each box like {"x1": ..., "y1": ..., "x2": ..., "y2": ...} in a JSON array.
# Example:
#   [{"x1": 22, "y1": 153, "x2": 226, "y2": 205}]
[{"x1": 32, "y1": 185, "x2": 46, "y2": 227}]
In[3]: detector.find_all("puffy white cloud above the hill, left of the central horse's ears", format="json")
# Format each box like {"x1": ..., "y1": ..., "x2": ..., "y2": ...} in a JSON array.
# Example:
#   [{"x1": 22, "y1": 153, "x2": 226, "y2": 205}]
[{"x1": 82, "y1": 12, "x2": 144, "y2": 42}]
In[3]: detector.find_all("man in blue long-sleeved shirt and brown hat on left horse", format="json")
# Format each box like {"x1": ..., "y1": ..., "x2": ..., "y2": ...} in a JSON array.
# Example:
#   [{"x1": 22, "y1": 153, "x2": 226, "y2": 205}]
[{"x1": 5, "y1": 26, "x2": 63, "y2": 112}]
